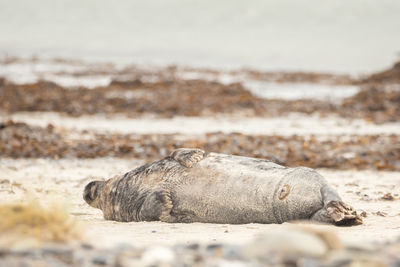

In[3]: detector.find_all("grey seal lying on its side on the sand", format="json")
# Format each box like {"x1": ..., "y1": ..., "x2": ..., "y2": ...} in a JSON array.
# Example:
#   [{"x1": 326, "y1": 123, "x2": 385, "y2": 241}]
[{"x1": 83, "y1": 148, "x2": 362, "y2": 225}]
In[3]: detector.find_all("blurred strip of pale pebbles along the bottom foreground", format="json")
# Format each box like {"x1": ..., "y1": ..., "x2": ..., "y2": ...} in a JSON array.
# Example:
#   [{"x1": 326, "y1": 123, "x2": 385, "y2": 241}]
[{"x1": 0, "y1": 230, "x2": 400, "y2": 267}]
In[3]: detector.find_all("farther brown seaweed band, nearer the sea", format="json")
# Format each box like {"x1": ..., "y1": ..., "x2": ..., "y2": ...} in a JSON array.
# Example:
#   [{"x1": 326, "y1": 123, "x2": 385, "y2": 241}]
[{"x1": 0, "y1": 76, "x2": 400, "y2": 123}]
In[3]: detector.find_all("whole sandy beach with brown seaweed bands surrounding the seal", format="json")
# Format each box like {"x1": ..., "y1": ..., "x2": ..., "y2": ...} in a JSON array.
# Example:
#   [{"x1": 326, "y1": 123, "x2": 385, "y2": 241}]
[{"x1": 0, "y1": 58, "x2": 400, "y2": 266}]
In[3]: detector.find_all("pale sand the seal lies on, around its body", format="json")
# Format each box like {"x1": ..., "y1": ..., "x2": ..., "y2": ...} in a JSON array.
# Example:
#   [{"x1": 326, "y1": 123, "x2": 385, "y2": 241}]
[{"x1": 0, "y1": 158, "x2": 400, "y2": 250}]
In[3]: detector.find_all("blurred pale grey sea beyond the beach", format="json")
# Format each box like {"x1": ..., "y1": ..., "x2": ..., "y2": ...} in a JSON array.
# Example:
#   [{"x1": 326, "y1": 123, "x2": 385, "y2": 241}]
[{"x1": 0, "y1": 0, "x2": 400, "y2": 74}]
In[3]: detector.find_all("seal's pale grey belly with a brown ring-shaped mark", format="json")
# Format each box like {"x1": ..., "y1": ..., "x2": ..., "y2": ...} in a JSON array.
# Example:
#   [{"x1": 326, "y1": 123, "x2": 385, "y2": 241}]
[{"x1": 173, "y1": 153, "x2": 322, "y2": 223}]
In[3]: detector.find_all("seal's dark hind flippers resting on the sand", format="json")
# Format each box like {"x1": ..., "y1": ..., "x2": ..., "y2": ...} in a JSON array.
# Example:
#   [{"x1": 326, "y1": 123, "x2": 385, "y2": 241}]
[{"x1": 311, "y1": 201, "x2": 363, "y2": 226}]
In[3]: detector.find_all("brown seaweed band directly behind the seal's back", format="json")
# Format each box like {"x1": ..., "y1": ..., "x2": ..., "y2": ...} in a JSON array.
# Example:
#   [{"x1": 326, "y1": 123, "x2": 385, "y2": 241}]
[{"x1": 0, "y1": 121, "x2": 400, "y2": 171}]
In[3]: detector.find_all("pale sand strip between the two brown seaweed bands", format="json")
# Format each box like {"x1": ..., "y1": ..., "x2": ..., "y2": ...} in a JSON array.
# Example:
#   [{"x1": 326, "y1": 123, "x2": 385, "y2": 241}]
[{"x1": 0, "y1": 112, "x2": 400, "y2": 136}]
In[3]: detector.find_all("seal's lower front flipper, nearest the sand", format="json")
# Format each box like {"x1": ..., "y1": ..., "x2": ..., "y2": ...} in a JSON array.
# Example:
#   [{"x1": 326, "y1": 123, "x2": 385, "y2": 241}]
[{"x1": 138, "y1": 190, "x2": 172, "y2": 221}]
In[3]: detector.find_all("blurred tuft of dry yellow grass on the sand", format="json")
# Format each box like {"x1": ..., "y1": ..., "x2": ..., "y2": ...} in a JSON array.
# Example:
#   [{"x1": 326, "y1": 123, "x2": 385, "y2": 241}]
[{"x1": 0, "y1": 200, "x2": 81, "y2": 243}]
